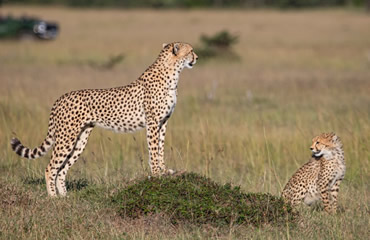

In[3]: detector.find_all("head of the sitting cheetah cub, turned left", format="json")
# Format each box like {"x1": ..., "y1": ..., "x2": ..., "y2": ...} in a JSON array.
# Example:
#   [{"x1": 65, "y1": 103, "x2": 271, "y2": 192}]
[{"x1": 310, "y1": 133, "x2": 342, "y2": 158}]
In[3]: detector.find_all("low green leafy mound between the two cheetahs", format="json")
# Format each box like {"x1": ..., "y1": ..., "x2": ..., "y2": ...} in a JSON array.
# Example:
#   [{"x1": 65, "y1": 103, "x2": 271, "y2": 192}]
[{"x1": 112, "y1": 173, "x2": 297, "y2": 227}]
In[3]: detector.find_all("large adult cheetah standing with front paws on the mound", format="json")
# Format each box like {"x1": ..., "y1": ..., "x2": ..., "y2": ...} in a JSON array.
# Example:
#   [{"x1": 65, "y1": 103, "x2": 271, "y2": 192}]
[{"x1": 11, "y1": 42, "x2": 198, "y2": 196}]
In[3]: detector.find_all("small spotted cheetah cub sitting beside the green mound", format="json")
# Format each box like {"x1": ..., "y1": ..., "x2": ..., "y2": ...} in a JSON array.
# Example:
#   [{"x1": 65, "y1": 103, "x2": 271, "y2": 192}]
[{"x1": 282, "y1": 133, "x2": 346, "y2": 213}]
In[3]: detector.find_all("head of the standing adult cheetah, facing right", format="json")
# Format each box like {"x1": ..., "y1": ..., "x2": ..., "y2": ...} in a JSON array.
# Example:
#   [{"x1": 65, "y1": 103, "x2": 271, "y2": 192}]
[{"x1": 161, "y1": 42, "x2": 198, "y2": 68}]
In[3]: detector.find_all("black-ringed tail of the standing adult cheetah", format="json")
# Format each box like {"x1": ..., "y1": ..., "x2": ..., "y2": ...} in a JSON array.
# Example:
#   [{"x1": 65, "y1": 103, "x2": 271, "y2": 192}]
[{"x1": 10, "y1": 136, "x2": 54, "y2": 159}]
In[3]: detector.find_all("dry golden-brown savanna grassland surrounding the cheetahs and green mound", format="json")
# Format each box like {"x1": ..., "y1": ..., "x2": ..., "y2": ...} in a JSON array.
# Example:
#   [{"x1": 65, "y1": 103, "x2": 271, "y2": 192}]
[{"x1": 0, "y1": 6, "x2": 370, "y2": 239}]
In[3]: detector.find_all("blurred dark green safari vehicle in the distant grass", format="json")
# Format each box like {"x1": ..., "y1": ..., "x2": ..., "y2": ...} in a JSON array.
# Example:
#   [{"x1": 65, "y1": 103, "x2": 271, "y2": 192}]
[{"x1": 0, "y1": 16, "x2": 59, "y2": 40}]
